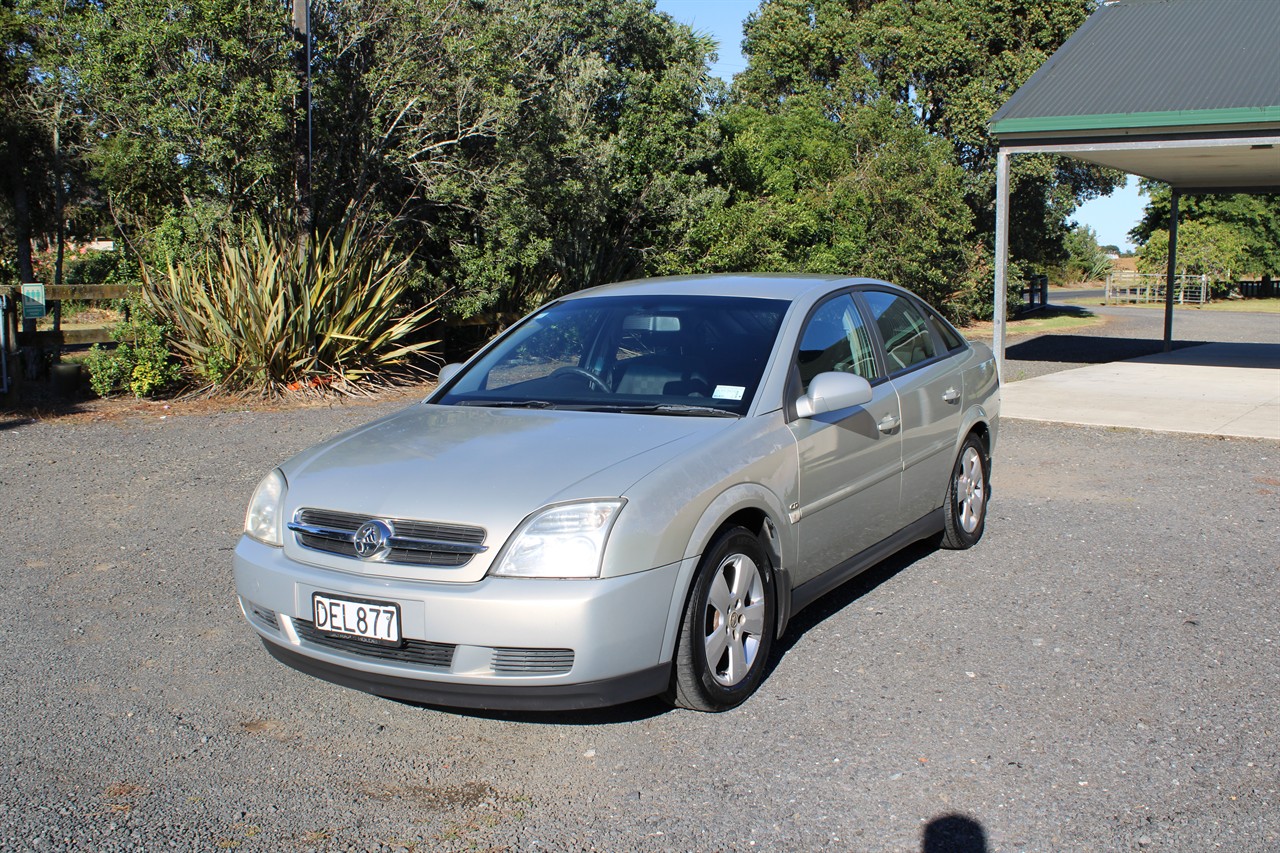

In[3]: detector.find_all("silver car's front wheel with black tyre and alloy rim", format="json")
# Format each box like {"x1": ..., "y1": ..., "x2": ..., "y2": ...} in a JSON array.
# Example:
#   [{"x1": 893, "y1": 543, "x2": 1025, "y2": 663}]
[{"x1": 666, "y1": 528, "x2": 777, "y2": 711}]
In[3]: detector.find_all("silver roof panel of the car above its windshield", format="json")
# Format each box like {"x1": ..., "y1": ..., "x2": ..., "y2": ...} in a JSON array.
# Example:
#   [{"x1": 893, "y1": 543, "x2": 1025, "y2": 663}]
[{"x1": 563, "y1": 273, "x2": 901, "y2": 302}]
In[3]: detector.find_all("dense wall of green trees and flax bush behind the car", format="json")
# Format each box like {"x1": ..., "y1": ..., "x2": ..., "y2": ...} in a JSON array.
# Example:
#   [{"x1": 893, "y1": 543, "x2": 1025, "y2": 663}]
[{"x1": 0, "y1": 0, "x2": 1141, "y2": 350}]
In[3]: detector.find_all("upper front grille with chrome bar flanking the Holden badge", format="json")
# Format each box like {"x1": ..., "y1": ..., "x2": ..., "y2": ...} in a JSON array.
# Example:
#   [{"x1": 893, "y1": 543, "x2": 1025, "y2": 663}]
[{"x1": 289, "y1": 508, "x2": 488, "y2": 569}]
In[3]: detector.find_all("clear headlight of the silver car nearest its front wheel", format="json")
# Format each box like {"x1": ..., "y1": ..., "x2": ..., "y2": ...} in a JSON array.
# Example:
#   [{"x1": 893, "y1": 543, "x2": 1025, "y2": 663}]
[{"x1": 492, "y1": 501, "x2": 626, "y2": 578}]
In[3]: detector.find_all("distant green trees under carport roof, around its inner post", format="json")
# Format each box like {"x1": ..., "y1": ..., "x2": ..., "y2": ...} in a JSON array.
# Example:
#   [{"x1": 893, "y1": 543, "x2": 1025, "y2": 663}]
[{"x1": 1129, "y1": 181, "x2": 1280, "y2": 275}]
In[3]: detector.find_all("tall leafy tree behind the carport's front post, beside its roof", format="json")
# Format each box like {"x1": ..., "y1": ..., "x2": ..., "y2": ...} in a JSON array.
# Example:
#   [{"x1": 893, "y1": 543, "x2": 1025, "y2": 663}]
[{"x1": 733, "y1": 0, "x2": 1123, "y2": 264}]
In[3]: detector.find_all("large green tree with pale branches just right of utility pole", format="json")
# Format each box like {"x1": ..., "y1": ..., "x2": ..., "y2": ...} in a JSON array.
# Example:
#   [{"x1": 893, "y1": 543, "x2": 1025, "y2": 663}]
[{"x1": 309, "y1": 0, "x2": 716, "y2": 316}]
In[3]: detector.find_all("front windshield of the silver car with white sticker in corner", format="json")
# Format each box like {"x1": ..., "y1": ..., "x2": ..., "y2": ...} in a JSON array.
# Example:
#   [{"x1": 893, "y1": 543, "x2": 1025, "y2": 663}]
[{"x1": 435, "y1": 295, "x2": 788, "y2": 416}]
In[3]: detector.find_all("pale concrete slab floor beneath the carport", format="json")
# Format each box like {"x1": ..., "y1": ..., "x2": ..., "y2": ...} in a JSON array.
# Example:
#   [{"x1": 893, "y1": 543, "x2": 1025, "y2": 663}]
[{"x1": 1000, "y1": 343, "x2": 1280, "y2": 441}]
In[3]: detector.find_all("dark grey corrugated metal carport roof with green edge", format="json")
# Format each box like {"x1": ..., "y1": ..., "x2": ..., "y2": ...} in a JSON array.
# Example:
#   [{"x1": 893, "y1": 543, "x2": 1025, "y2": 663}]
[{"x1": 992, "y1": 0, "x2": 1280, "y2": 136}]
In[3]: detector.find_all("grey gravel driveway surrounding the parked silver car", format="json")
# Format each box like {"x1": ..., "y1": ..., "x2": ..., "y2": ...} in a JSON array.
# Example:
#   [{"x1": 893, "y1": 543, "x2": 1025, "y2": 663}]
[{"x1": 0, "y1": 394, "x2": 1280, "y2": 853}]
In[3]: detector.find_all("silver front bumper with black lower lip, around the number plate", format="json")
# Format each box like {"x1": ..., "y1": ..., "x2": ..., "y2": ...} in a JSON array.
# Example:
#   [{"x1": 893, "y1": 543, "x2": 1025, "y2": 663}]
[{"x1": 234, "y1": 538, "x2": 680, "y2": 710}]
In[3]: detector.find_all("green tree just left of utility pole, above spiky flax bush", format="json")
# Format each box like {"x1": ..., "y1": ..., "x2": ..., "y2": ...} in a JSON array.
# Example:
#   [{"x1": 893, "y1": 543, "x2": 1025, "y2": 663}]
[{"x1": 76, "y1": 0, "x2": 296, "y2": 256}]
